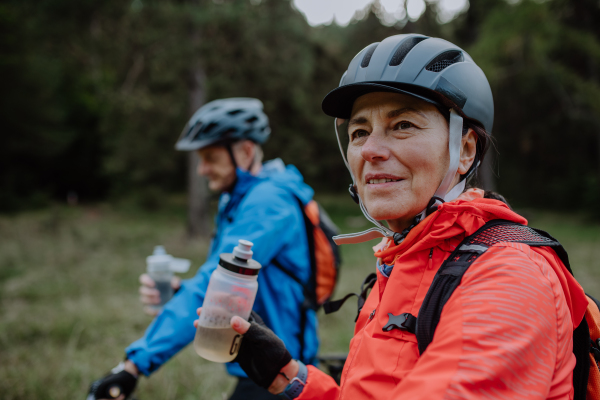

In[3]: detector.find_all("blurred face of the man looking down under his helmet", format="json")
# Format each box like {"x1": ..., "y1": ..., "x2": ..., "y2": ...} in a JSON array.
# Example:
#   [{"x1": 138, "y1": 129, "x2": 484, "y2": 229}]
[{"x1": 197, "y1": 146, "x2": 236, "y2": 192}]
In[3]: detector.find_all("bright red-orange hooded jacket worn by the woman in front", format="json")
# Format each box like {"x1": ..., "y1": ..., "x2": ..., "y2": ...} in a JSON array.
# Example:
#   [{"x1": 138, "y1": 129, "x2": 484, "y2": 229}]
[{"x1": 298, "y1": 189, "x2": 587, "y2": 400}]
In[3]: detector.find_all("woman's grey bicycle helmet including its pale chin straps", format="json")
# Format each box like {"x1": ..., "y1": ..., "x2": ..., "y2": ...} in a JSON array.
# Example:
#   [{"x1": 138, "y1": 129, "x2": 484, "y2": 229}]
[{"x1": 322, "y1": 34, "x2": 494, "y2": 244}]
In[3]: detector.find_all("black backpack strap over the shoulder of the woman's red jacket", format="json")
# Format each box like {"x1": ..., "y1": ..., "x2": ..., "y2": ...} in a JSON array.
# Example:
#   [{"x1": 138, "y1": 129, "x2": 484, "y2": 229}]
[{"x1": 416, "y1": 220, "x2": 591, "y2": 400}]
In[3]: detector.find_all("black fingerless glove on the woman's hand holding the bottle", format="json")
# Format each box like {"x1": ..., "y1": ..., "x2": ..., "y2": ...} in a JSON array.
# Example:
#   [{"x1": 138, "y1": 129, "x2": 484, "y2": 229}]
[{"x1": 233, "y1": 311, "x2": 292, "y2": 389}]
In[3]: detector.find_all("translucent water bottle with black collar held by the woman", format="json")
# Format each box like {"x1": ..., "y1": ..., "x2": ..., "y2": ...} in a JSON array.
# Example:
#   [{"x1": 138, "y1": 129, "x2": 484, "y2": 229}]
[{"x1": 194, "y1": 240, "x2": 261, "y2": 363}]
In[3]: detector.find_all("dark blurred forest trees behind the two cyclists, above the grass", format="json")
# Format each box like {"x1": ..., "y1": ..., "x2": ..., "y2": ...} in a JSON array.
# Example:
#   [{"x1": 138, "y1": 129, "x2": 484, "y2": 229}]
[{"x1": 0, "y1": 0, "x2": 600, "y2": 211}]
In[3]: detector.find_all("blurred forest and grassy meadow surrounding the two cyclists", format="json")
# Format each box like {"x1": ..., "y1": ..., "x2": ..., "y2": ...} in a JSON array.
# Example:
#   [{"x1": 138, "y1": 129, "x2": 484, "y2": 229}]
[{"x1": 0, "y1": 0, "x2": 600, "y2": 400}]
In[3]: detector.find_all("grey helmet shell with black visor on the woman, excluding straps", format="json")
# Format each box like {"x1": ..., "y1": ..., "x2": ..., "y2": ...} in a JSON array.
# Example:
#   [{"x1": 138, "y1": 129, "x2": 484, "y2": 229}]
[{"x1": 322, "y1": 34, "x2": 494, "y2": 133}]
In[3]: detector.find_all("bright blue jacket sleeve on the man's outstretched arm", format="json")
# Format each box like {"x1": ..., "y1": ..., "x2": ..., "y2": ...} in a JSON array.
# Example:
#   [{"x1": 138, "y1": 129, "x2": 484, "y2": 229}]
[{"x1": 125, "y1": 182, "x2": 302, "y2": 376}]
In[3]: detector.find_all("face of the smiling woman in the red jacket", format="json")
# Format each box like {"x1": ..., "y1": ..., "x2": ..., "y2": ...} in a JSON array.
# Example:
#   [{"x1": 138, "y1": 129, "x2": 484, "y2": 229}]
[{"x1": 348, "y1": 92, "x2": 460, "y2": 232}]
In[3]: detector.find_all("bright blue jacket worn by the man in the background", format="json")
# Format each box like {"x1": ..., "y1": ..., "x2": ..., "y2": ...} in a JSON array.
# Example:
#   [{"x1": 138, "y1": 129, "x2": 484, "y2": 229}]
[{"x1": 125, "y1": 159, "x2": 319, "y2": 377}]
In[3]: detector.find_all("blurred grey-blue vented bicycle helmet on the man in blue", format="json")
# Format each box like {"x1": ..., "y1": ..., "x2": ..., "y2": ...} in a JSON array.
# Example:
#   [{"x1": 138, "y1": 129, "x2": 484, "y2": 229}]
[{"x1": 175, "y1": 97, "x2": 271, "y2": 151}]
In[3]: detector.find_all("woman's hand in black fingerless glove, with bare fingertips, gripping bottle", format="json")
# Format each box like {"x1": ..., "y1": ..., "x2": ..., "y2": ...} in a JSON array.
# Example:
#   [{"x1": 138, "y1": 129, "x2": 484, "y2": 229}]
[{"x1": 194, "y1": 308, "x2": 298, "y2": 394}]
